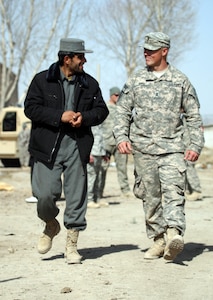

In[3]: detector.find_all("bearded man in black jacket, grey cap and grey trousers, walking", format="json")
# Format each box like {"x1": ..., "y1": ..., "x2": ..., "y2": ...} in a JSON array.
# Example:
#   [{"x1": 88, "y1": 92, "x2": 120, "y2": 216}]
[{"x1": 25, "y1": 39, "x2": 108, "y2": 263}]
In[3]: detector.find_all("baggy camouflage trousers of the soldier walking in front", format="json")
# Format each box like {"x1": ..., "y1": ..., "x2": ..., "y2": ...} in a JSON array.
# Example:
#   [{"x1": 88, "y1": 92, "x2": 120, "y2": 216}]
[{"x1": 133, "y1": 152, "x2": 186, "y2": 238}]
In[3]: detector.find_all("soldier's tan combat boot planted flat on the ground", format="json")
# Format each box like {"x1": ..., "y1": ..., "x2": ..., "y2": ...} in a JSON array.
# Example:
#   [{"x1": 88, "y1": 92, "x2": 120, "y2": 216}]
[{"x1": 144, "y1": 233, "x2": 166, "y2": 259}]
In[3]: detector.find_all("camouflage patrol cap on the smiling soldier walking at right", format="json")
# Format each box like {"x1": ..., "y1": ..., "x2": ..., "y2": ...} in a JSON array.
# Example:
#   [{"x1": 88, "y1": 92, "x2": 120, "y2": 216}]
[{"x1": 143, "y1": 32, "x2": 170, "y2": 50}]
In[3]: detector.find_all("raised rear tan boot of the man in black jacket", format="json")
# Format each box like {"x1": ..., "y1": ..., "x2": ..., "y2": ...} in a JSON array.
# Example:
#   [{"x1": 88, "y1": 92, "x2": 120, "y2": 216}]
[{"x1": 38, "y1": 219, "x2": 61, "y2": 254}]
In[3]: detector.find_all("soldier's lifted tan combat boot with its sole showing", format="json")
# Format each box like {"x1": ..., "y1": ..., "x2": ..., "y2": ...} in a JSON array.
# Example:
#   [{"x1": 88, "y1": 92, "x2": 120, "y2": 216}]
[{"x1": 163, "y1": 228, "x2": 184, "y2": 260}]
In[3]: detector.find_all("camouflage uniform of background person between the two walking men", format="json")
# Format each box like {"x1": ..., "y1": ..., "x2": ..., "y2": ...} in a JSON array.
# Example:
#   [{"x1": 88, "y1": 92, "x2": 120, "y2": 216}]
[{"x1": 101, "y1": 103, "x2": 130, "y2": 194}]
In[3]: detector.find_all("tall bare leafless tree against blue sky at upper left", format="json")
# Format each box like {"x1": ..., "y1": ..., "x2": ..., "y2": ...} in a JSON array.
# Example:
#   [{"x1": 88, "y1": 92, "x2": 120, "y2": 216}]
[{"x1": 0, "y1": 0, "x2": 88, "y2": 110}]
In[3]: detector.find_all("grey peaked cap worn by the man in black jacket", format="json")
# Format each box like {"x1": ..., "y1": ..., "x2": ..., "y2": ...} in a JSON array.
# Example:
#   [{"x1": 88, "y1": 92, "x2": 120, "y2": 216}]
[{"x1": 59, "y1": 38, "x2": 93, "y2": 53}]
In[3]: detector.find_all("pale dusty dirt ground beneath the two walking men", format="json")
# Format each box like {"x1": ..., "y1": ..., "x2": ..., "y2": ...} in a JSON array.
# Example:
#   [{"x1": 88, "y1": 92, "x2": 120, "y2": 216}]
[{"x1": 0, "y1": 153, "x2": 213, "y2": 300}]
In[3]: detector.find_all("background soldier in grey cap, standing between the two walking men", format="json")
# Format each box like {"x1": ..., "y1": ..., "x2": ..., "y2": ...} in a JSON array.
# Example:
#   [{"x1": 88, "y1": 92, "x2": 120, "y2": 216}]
[{"x1": 100, "y1": 86, "x2": 133, "y2": 197}]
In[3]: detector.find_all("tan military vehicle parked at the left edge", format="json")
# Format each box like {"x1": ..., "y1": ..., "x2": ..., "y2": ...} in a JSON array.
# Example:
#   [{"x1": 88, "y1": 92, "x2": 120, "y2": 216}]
[{"x1": 0, "y1": 106, "x2": 31, "y2": 167}]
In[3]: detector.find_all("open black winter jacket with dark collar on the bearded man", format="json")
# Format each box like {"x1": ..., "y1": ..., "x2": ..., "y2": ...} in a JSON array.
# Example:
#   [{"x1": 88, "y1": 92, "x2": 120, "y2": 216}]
[{"x1": 24, "y1": 62, "x2": 109, "y2": 164}]
